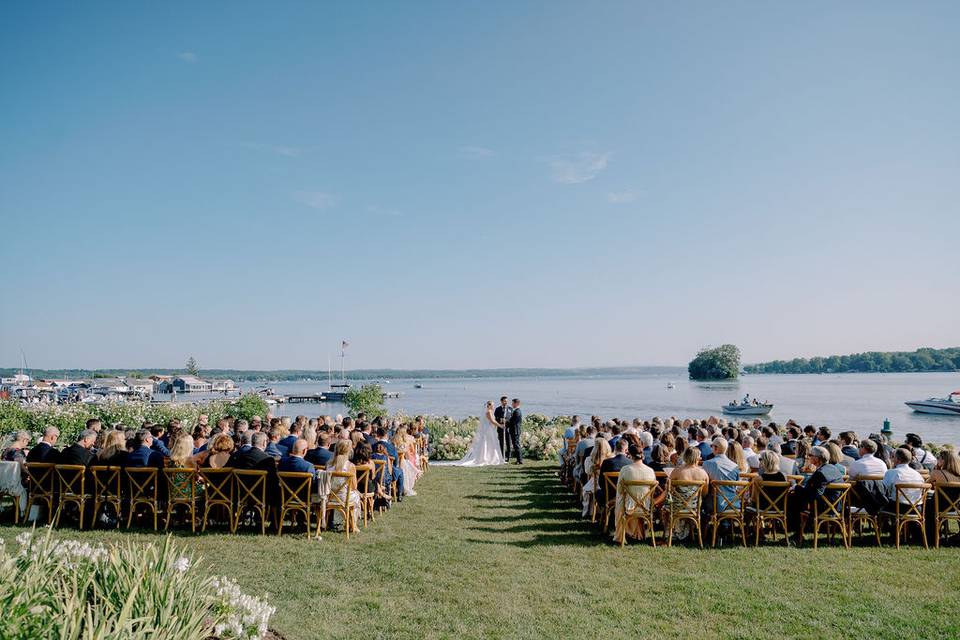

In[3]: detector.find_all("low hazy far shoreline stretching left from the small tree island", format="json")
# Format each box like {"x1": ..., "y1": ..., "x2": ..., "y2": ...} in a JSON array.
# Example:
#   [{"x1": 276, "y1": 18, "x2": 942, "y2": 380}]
[{"x1": 0, "y1": 367, "x2": 686, "y2": 382}]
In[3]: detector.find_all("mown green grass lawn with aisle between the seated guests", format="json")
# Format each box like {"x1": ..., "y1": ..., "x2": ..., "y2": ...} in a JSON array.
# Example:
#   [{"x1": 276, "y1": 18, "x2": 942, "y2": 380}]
[{"x1": 0, "y1": 463, "x2": 960, "y2": 640}]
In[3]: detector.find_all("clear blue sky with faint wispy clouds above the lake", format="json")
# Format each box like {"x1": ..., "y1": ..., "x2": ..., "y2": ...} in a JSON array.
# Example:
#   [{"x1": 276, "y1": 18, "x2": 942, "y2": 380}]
[{"x1": 0, "y1": 2, "x2": 960, "y2": 369}]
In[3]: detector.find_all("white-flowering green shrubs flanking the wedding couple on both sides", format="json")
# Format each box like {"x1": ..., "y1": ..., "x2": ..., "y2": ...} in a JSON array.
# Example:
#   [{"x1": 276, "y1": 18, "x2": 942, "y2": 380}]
[{"x1": 425, "y1": 413, "x2": 570, "y2": 460}]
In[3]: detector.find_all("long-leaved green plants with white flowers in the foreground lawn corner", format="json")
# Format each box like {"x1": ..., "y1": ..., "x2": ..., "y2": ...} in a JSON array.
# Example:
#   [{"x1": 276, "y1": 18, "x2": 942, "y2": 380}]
[{"x1": 0, "y1": 530, "x2": 274, "y2": 640}]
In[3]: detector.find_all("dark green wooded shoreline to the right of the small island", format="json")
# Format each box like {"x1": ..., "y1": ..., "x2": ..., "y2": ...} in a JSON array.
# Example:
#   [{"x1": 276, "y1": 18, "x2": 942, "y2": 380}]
[{"x1": 743, "y1": 347, "x2": 960, "y2": 373}]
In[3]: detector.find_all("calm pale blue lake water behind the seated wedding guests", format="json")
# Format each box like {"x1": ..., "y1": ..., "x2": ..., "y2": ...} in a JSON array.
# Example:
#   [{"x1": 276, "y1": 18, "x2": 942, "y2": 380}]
[{"x1": 199, "y1": 372, "x2": 960, "y2": 444}]
